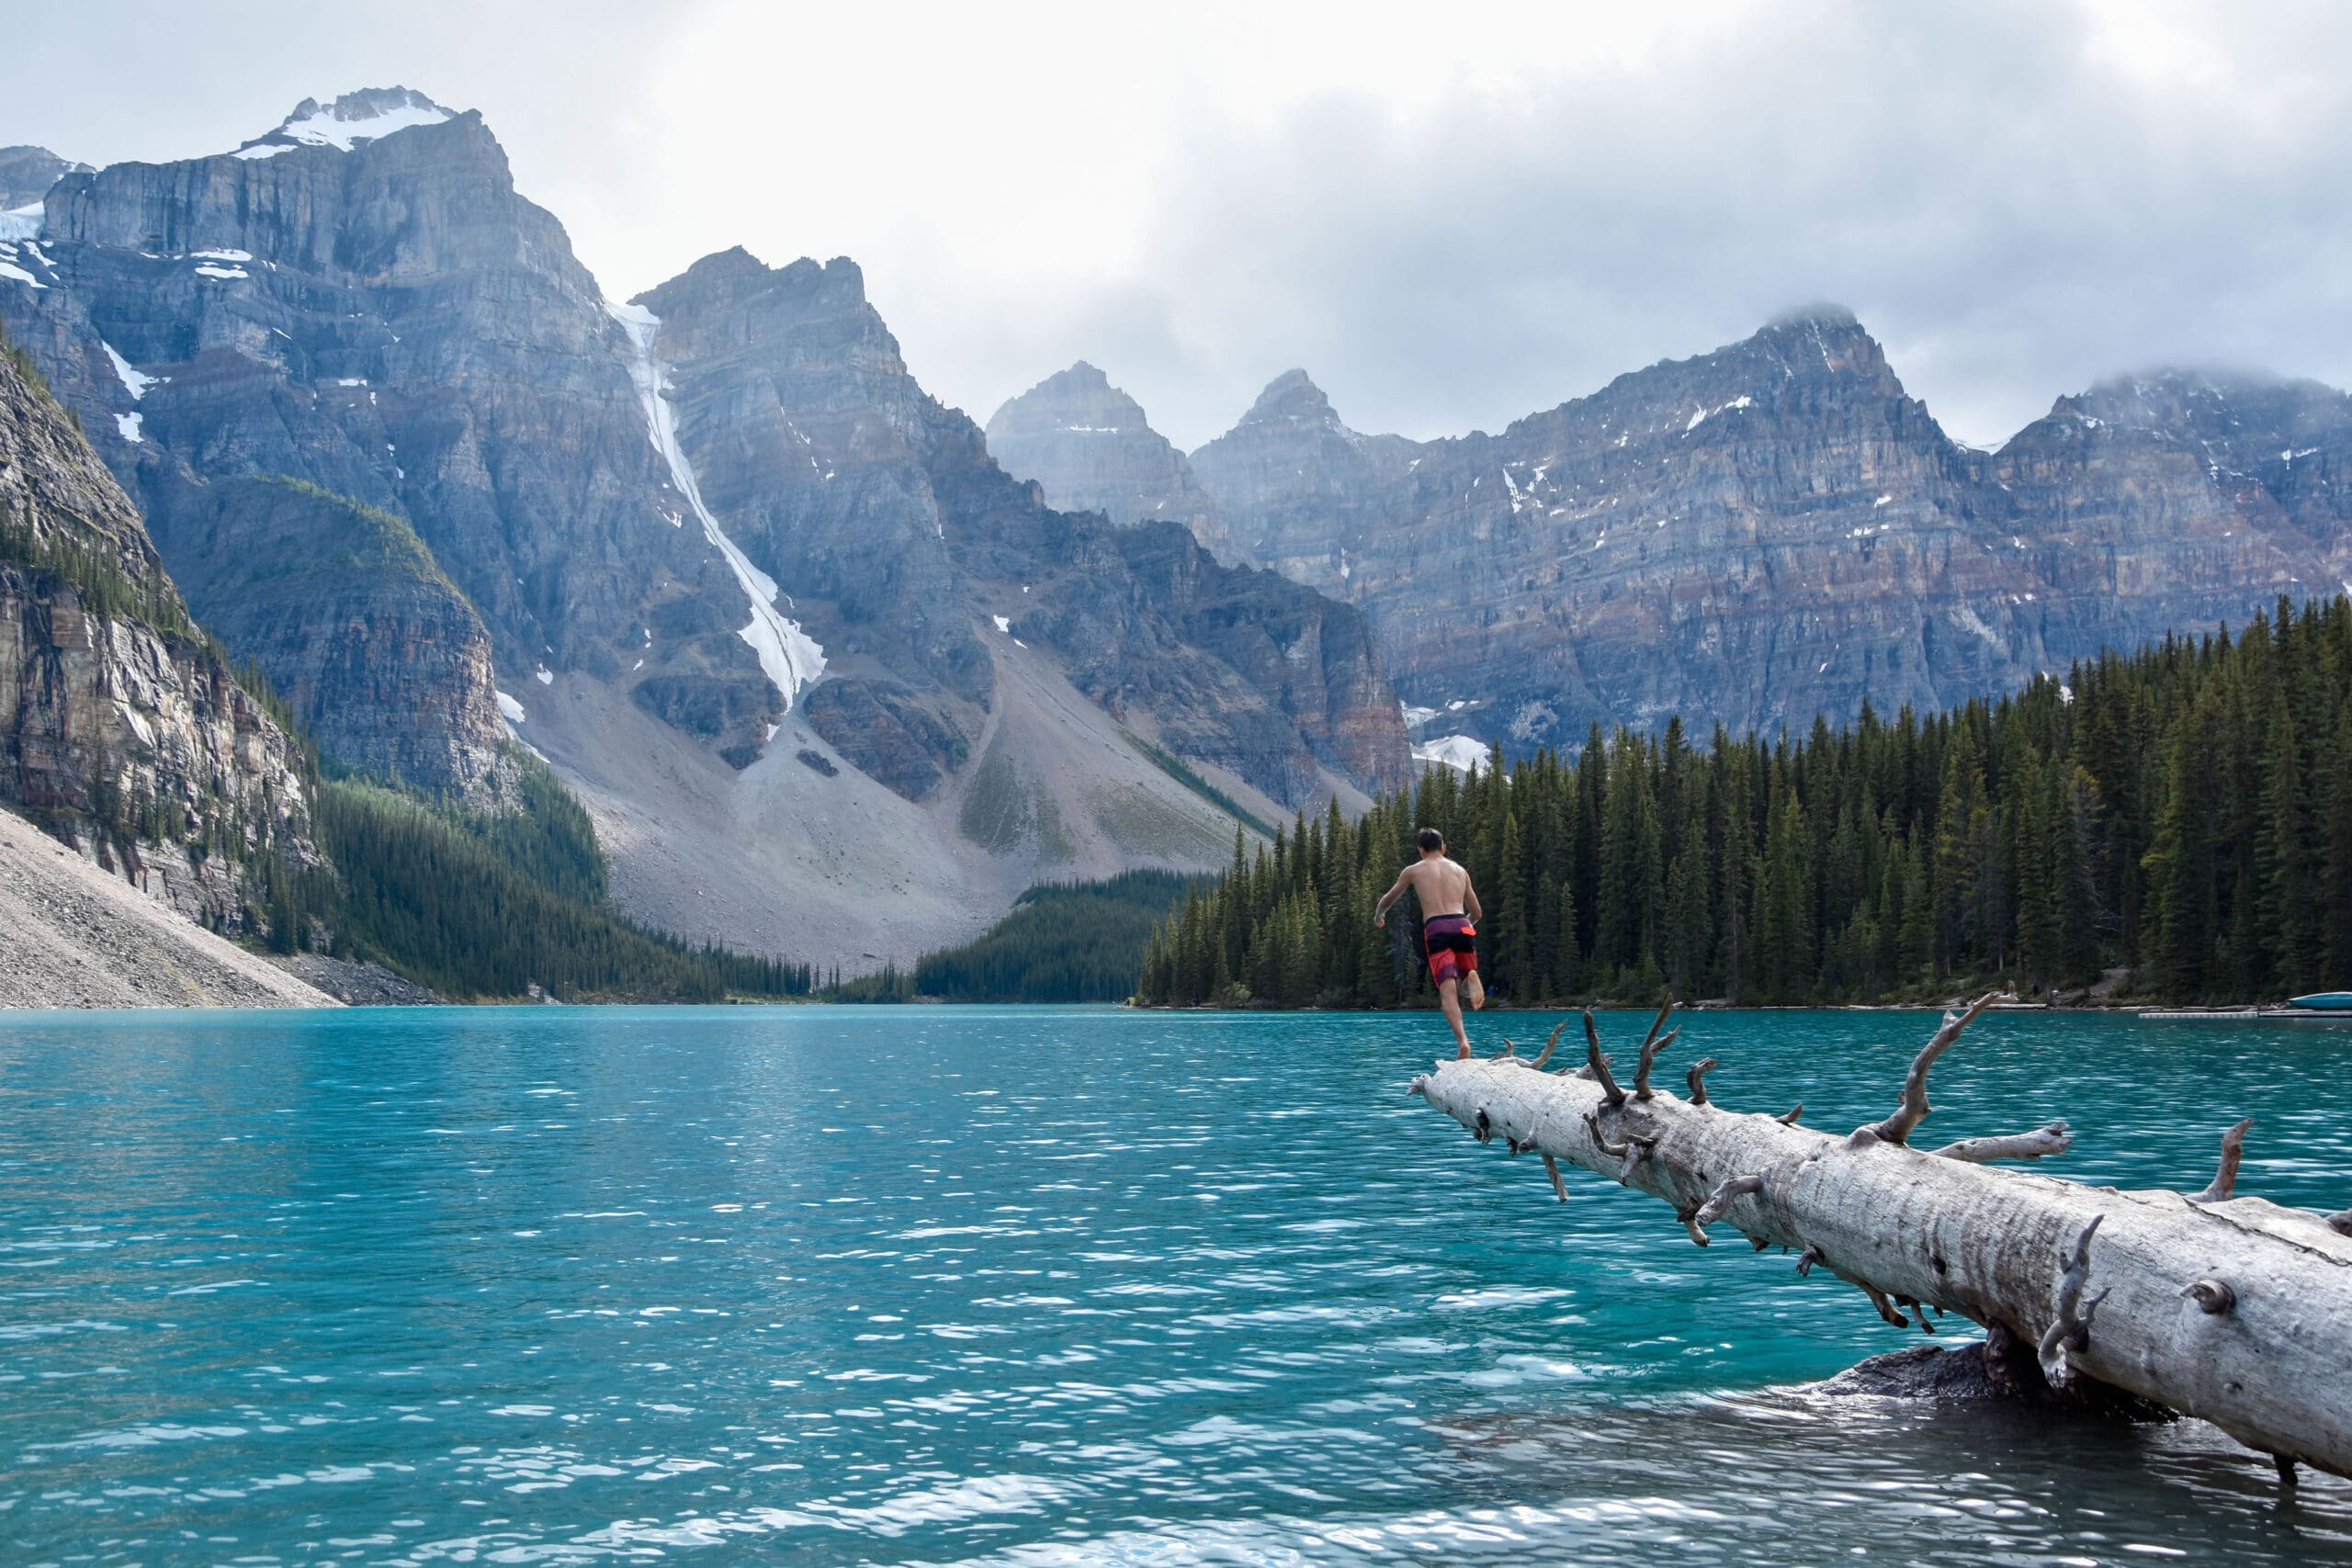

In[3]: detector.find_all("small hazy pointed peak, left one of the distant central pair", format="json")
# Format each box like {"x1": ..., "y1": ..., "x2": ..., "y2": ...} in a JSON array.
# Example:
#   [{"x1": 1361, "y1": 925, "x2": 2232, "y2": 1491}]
[{"x1": 988, "y1": 360, "x2": 1218, "y2": 538}]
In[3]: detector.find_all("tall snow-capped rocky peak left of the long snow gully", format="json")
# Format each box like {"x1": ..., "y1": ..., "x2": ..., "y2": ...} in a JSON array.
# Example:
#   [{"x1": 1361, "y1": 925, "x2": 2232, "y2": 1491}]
[{"x1": 0, "y1": 89, "x2": 742, "y2": 792}]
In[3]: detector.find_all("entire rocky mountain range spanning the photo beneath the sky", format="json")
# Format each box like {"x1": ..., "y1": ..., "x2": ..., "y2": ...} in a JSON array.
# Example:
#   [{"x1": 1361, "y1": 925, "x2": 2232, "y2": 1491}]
[{"x1": 0, "y1": 87, "x2": 2352, "y2": 971}]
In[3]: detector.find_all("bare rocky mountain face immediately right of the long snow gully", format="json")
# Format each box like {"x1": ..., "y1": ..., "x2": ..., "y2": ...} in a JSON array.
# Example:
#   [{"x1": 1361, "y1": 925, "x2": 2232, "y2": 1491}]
[{"x1": 635, "y1": 252, "x2": 1407, "y2": 804}]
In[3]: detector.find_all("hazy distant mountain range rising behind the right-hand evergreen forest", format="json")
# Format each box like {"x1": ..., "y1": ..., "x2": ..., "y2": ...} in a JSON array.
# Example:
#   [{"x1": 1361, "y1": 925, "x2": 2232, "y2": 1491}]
[{"x1": 988, "y1": 308, "x2": 2352, "y2": 764}]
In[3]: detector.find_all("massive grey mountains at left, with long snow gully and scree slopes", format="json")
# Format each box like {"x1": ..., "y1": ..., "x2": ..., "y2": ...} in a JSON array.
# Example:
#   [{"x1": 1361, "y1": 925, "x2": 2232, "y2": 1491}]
[{"x1": 0, "y1": 87, "x2": 1411, "y2": 968}]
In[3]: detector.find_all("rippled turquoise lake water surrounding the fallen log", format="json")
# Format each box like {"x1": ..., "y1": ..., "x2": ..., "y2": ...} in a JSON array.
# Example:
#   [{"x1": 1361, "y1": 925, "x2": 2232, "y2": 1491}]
[{"x1": 0, "y1": 1009, "x2": 2352, "y2": 1563}]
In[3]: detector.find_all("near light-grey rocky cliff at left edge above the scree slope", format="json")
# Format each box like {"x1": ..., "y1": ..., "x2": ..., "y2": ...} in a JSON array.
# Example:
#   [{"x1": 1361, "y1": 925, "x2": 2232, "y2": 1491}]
[{"x1": 0, "y1": 331, "x2": 311, "y2": 924}]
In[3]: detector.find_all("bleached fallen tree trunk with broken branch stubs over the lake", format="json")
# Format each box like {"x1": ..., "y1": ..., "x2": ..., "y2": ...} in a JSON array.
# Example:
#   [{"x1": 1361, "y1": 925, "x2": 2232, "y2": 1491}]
[{"x1": 1411, "y1": 997, "x2": 2352, "y2": 1479}]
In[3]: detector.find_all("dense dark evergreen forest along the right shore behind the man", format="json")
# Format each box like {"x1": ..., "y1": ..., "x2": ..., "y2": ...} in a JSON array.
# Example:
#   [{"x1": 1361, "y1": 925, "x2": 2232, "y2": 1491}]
[{"x1": 1138, "y1": 597, "x2": 2352, "y2": 1006}]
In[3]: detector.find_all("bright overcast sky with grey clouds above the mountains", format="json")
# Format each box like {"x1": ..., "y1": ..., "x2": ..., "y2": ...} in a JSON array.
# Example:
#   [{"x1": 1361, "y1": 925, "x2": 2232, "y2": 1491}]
[{"x1": 0, "y1": 0, "x2": 2352, "y2": 446}]
